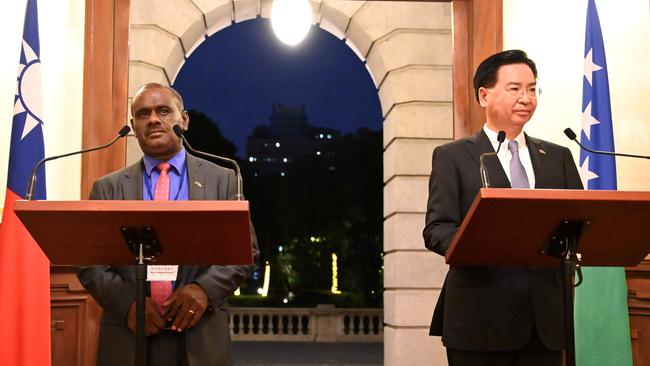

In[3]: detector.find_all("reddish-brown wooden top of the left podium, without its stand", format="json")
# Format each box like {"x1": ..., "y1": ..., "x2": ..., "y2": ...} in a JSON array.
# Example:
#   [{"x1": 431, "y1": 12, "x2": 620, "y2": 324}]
[{"x1": 14, "y1": 200, "x2": 253, "y2": 265}]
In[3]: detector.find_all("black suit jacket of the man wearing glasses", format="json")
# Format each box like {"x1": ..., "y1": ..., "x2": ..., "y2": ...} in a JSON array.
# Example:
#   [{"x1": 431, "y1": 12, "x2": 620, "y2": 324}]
[{"x1": 423, "y1": 130, "x2": 582, "y2": 351}]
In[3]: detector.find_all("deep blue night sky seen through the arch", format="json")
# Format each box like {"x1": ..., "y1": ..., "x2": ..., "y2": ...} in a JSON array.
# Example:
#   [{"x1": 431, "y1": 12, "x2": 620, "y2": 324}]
[{"x1": 173, "y1": 18, "x2": 382, "y2": 157}]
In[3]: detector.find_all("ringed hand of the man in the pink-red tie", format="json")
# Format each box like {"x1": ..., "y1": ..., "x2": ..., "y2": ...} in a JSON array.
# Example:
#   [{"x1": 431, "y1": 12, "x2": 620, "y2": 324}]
[{"x1": 161, "y1": 283, "x2": 208, "y2": 332}]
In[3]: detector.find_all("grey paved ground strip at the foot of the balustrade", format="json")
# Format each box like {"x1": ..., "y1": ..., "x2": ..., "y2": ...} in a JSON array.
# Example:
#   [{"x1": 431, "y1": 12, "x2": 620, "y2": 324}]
[{"x1": 233, "y1": 342, "x2": 384, "y2": 366}]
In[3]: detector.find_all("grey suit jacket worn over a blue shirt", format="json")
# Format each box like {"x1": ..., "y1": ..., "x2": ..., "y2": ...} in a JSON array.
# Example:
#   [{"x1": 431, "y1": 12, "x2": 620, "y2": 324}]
[{"x1": 77, "y1": 154, "x2": 259, "y2": 365}]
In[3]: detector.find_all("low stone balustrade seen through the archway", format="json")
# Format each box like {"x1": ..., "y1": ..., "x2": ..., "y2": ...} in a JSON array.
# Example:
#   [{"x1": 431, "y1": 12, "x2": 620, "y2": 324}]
[{"x1": 230, "y1": 305, "x2": 384, "y2": 342}]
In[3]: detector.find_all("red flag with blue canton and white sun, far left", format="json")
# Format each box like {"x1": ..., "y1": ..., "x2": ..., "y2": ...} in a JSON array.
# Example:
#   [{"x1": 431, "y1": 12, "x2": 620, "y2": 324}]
[{"x1": 0, "y1": 0, "x2": 51, "y2": 366}]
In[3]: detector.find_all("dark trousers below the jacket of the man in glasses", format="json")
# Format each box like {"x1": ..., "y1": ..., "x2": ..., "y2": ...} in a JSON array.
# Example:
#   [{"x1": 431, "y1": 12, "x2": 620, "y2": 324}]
[{"x1": 447, "y1": 329, "x2": 562, "y2": 366}]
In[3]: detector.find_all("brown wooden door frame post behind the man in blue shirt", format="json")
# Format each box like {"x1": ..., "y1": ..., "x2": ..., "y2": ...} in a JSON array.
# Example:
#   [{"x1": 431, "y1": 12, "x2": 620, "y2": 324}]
[{"x1": 81, "y1": 0, "x2": 130, "y2": 199}]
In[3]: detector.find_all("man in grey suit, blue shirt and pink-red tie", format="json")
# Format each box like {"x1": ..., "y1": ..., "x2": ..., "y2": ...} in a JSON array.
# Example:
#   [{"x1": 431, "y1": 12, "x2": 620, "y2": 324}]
[{"x1": 77, "y1": 84, "x2": 259, "y2": 366}]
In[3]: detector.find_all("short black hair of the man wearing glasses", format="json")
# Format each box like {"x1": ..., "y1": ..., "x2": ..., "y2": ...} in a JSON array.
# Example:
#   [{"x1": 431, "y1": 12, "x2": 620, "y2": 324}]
[{"x1": 474, "y1": 50, "x2": 537, "y2": 101}]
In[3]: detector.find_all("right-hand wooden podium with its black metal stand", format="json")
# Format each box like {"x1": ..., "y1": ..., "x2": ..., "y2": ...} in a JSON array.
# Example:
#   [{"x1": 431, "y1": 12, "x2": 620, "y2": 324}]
[{"x1": 445, "y1": 188, "x2": 650, "y2": 366}]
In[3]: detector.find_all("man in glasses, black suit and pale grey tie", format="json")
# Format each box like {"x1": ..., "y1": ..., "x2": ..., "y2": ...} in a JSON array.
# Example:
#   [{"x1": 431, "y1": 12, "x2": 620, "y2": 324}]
[{"x1": 423, "y1": 50, "x2": 582, "y2": 366}]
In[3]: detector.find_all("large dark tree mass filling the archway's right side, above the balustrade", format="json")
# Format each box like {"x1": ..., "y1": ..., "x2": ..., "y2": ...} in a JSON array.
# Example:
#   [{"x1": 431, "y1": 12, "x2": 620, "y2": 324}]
[{"x1": 251, "y1": 129, "x2": 383, "y2": 306}]
